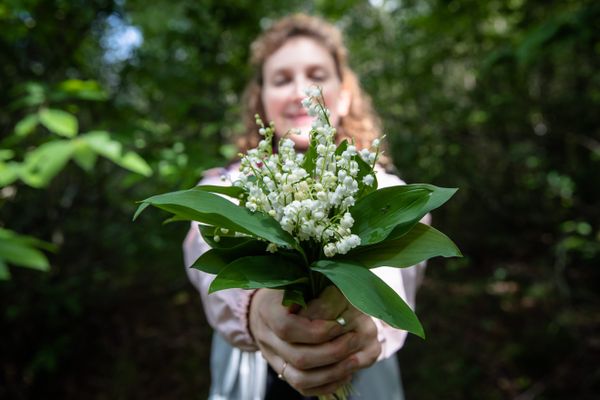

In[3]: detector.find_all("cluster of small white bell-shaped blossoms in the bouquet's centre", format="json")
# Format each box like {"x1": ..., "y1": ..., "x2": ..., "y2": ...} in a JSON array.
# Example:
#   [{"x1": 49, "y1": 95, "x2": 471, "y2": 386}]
[{"x1": 234, "y1": 87, "x2": 379, "y2": 257}]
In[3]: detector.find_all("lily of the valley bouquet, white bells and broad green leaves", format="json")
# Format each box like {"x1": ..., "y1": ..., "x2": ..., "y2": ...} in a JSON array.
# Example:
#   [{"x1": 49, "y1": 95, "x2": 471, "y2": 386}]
[{"x1": 134, "y1": 87, "x2": 460, "y2": 398}]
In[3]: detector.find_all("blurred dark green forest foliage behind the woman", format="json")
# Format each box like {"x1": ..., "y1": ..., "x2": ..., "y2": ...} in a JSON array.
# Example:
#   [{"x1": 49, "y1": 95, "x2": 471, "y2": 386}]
[{"x1": 0, "y1": 0, "x2": 600, "y2": 399}]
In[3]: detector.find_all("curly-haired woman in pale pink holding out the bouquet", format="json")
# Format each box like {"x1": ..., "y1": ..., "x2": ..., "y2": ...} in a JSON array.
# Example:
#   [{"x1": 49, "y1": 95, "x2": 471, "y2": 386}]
[{"x1": 184, "y1": 15, "x2": 422, "y2": 399}]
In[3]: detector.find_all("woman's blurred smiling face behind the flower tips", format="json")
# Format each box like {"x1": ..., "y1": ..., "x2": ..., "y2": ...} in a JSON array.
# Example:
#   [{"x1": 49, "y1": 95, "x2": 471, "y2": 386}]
[{"x1": 262, "y1": 36, "x2": 350, "y2": 150}]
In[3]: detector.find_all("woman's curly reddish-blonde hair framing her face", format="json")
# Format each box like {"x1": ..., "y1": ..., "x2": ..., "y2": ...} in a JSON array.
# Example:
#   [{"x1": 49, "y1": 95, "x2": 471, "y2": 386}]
[{"x1": 239, "y1": 14, "x2": 380, "y2": 156}]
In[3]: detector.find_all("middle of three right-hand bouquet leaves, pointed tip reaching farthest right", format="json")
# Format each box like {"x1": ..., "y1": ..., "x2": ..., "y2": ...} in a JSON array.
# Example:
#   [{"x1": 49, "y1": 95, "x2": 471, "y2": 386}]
[{"x1": 340, "y1": 223, "x2": 461, "y2": 268}]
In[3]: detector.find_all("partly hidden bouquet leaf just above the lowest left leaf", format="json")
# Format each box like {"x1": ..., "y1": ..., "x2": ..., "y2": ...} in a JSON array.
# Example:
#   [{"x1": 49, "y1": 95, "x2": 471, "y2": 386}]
[{"x1": 192, "y1": 240, "x2": 267, "y2": 274}]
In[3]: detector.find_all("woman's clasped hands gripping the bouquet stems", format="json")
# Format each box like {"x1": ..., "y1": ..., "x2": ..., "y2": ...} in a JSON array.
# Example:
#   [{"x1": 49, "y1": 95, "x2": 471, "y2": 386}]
[{"x1": 249, "y1": 288, "x2": 381, "y2": 396}]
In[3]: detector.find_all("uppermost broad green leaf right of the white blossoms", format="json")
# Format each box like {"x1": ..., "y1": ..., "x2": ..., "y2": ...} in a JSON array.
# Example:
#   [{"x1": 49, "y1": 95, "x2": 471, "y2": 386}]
[{"x1": 350, "y1": 185, "x2": 431, "y2": 246}]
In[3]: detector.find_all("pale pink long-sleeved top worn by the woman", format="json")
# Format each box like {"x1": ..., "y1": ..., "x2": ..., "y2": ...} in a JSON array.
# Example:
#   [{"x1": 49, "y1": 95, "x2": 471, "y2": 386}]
[{"x1": 183, "y1": 164, "x2": 430, "y2": 359}]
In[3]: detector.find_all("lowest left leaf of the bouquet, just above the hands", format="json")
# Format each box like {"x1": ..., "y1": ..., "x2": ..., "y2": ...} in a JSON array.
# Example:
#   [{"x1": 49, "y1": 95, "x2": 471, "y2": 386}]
[{"x1": 208, "y1": 255, "x2": 308, "y2": 293}]
